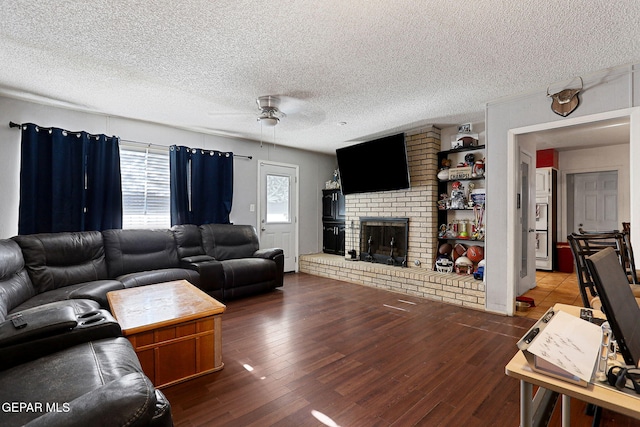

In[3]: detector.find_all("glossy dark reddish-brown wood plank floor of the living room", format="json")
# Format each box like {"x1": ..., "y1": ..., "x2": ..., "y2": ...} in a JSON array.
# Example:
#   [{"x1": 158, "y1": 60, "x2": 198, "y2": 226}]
[{"x1": 164, "y1": 274, "x2": 640, "y2": 427}]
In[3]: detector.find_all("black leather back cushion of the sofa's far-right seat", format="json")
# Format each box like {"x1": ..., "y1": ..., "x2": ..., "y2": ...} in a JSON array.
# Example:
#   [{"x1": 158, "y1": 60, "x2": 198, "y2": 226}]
[{"x1": 200, "y1": 224, "x2": 260, "y2": 261}]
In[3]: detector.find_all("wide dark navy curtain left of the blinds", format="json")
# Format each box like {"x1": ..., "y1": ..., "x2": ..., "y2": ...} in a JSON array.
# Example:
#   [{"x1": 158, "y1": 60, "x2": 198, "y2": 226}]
[{"x1": 18, "y1": 123, "x2": 122, "y2": 234}]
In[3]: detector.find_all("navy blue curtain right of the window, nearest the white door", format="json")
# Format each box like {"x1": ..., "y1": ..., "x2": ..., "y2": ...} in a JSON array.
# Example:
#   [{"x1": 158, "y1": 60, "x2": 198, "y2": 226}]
[{"x1": 170, "y1": 145, "x2": 233, "y2": 225}]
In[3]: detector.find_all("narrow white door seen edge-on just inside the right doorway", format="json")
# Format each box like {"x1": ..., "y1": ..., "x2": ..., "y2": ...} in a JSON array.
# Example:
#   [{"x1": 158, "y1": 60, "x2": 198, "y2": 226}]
[{"x1": 516, "y1": 151, "x2": 536, "y2": 295}]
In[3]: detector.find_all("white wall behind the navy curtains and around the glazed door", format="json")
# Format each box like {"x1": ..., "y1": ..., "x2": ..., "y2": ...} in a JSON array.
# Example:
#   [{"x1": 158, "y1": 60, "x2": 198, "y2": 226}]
[{"x1": 0, "y1": 97, "x2": 336, "y2": 254}]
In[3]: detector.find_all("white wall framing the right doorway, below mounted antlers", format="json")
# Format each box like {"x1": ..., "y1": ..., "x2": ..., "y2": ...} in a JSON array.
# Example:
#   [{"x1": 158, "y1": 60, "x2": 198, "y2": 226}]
[{"x1": 485, "y1": 66, "x2": 640, "y2": 313}]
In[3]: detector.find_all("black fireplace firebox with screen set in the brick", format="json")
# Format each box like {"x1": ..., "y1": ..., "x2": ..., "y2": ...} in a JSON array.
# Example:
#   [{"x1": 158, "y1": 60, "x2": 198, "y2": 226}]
[{"x1": 360, "y1": 217, "x2": 409, "y2": 267}]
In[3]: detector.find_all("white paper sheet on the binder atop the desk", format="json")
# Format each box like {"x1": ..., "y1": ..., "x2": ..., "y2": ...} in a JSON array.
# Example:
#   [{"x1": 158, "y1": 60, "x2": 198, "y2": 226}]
[{"x1": 528, "y1": 311, "x2": 602, "y2": 382}]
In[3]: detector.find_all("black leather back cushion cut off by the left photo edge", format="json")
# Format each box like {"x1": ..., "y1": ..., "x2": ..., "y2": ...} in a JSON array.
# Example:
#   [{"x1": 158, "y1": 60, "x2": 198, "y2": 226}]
[{"x1": 0, "y1": 239, "x2": 36, "y2": 322}]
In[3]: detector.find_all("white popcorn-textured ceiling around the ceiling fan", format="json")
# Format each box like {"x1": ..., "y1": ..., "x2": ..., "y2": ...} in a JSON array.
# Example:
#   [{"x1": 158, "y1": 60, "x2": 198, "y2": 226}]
[{"x1": 0, "y1": 0, "x2": 640, "y2": 153}]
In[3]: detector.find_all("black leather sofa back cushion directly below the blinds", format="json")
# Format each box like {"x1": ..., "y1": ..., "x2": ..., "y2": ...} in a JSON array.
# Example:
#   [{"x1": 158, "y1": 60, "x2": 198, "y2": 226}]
[{"x1": 102, "y1": 230, "x2": 179, "y2": 278}]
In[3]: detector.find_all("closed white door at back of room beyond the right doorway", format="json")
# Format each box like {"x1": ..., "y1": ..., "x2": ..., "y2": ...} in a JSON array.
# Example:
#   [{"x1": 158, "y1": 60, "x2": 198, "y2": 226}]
[{"x1": 573, "y1": 171, "x2": 620, "y2": 233}]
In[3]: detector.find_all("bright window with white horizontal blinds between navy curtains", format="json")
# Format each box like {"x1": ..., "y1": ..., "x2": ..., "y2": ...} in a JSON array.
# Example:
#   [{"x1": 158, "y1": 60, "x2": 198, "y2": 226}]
[{"x1": 120, "y1": 144, "x2": 171, "y2": 228}]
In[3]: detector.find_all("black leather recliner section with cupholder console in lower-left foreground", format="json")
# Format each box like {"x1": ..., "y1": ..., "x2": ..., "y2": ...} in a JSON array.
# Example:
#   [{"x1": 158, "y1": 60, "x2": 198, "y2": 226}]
[{"x1": 0, "y1": 240, "x2": 173, "y2": 427}]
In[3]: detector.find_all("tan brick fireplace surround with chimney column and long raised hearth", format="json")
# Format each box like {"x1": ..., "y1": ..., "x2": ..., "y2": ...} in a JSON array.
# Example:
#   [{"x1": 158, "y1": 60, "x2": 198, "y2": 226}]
[{"x1": 299, "y1": 127, "x2": 485, "y2": 310}]
